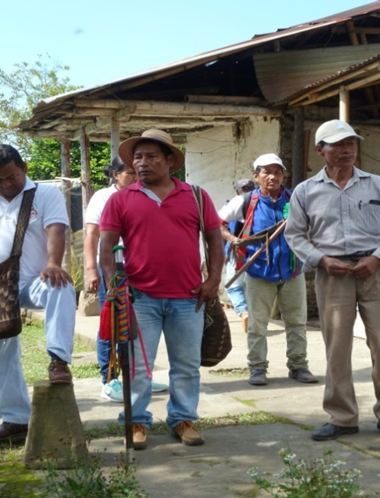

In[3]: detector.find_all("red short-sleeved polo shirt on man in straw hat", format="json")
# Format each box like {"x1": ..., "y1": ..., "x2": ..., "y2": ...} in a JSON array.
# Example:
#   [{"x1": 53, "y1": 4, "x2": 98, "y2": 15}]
[{"x1": 100, "y1": 178, "x2": 220, "y2": 299}]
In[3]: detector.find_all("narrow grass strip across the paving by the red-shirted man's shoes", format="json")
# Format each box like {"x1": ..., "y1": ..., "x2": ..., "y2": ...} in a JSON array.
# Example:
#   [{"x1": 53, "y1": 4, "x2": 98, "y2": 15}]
[{"x1": 84, "y1": 412, "x2": 292, "y2": 441}]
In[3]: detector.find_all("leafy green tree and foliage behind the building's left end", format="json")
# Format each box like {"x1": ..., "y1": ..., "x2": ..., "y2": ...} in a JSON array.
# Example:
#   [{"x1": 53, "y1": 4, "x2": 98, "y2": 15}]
[{"x1": 0, "y1": 54, "x2": 110, "y2": 188}]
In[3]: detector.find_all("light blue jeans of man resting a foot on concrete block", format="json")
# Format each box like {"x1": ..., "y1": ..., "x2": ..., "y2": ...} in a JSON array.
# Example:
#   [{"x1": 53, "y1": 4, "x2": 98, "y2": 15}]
[{"x1": 0, "y1": 276, "x2": 76, "y2": 424}]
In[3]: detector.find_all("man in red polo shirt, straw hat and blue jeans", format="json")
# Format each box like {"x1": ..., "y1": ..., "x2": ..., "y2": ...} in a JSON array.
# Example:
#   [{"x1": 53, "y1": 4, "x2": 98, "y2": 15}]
[{"x1": 100, "y1": 130, "x2": 224, "y2": 449}]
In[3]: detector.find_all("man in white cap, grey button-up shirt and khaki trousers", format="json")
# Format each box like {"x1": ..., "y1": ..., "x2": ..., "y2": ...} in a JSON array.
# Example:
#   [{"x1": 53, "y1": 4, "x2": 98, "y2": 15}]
[{"x1": 285, "y1": 119, "x2": 380, "y2": 441}]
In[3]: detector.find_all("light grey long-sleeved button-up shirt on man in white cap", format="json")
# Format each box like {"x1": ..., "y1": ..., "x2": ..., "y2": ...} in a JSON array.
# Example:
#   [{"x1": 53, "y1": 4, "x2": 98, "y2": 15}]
[{"x1": 285, "y1": 166, "x2": 380, "y2": 271}]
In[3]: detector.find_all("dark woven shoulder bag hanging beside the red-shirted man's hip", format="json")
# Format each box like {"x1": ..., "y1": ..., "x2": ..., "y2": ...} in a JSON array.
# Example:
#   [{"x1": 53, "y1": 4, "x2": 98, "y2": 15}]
[{"x1": 191, "y1": 185, "x2": 232, "y2": 367}]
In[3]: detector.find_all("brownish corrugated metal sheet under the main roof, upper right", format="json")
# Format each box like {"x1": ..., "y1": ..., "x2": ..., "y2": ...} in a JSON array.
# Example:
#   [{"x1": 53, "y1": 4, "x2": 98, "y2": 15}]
[{"x1": 253, "y1": 43, "x2": 380, "y2": 104}]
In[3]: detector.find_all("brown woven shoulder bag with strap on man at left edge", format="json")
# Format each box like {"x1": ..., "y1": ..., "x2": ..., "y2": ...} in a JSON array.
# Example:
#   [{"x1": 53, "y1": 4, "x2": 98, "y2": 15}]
[{"x1": 0, "y1": 188, "x2": 36, "y2": 339}]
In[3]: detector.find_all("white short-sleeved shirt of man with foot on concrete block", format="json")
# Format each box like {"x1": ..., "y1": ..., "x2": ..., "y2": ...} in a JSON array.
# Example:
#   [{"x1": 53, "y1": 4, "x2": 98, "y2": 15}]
[{"x1": 0, "y1": 177, "x2": 69, "y2": 290}]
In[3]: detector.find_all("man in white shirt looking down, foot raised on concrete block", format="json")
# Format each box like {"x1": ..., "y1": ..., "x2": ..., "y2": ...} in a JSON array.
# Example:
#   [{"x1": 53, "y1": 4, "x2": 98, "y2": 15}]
[{"x1": 0, "y1": 144, "x2": 76, "y2": 442}]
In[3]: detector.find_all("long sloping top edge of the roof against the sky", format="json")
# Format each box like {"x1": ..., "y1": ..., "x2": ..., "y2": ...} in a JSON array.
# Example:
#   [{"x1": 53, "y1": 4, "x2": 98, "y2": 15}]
[{"x1": 31, "y1": 0, "x2": 380, "y2": 112}]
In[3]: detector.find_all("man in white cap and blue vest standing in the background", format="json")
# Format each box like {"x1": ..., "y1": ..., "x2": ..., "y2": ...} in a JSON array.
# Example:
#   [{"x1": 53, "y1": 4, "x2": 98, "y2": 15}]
[{"x1": 219, "y1": 154, "x2": 318, "y2": 386}]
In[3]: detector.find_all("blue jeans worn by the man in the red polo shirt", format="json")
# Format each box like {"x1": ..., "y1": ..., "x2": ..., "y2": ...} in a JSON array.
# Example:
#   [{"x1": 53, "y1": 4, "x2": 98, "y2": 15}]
[{"x1": 119, "y1": 291, "x2": 204, "y2": 428}]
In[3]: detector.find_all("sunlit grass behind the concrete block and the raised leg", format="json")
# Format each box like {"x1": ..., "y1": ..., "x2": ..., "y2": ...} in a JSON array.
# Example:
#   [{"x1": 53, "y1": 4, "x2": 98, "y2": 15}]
[{"x1": 20, "y1": 323, "x2": 100, "y2": 385}]
